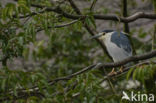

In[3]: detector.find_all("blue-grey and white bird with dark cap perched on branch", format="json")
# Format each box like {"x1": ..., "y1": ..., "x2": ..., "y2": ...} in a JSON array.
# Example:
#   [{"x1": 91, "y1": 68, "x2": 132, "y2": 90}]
[{"x1": 91, "y1": 30, "x2": 133, "y2": 73}]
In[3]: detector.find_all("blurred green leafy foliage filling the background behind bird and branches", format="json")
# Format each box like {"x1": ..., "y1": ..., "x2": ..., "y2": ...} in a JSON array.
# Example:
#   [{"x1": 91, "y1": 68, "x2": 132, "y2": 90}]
[{"x1": 0, "y1": 0, "x2": 156, "y2": 103}]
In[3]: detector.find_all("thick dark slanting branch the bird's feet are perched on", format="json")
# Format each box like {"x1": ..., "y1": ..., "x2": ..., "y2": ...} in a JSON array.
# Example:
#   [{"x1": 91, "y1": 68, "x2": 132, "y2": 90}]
[{"x1": 19, "y1": 50, "x2": 156, "y2": 88}]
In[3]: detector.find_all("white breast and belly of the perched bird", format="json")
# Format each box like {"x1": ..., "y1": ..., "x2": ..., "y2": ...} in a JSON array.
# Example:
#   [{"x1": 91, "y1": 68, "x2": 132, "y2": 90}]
[{"x1": 104, "y1": 33, "x2": 132, "y2": 62}]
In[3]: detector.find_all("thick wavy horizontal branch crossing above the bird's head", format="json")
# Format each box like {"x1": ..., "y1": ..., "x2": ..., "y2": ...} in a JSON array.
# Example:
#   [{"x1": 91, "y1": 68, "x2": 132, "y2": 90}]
[{"x1": 16, "y1": 4, "x2": 156, "y2": 23}]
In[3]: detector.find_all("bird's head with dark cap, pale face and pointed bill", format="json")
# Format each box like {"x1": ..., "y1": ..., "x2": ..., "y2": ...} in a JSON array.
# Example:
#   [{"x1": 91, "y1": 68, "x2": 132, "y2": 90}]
[{"x1": 91, "y1": 30, "x2": 114, "y2": 40}]
